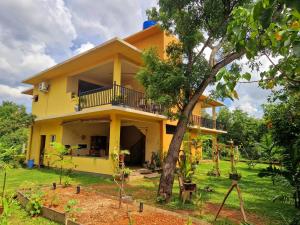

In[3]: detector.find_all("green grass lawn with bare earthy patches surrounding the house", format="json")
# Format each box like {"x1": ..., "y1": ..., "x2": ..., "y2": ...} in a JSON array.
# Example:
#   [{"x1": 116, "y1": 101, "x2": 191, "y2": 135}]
[{"x1": 1, "y1": 161, "x2": 296, "y2": 225}]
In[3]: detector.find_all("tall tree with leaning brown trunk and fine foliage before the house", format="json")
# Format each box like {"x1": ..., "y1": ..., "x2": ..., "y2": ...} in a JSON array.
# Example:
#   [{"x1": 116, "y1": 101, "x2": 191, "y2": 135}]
[{"x1": 138, "y1": 0, "x2": 250, "y2": 201}]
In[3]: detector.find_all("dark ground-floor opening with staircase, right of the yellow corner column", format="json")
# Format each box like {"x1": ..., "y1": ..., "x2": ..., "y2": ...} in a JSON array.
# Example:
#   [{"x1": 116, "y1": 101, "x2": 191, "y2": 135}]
[{"x1": 120, "y1": 126, "x2": 146, "y2": 166}]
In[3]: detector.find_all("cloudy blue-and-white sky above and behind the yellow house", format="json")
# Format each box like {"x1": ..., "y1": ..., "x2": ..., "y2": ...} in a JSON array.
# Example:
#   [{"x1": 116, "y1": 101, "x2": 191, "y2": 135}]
[{"x1": 0, "y1": 0, "x2": 269, "y2": 117}]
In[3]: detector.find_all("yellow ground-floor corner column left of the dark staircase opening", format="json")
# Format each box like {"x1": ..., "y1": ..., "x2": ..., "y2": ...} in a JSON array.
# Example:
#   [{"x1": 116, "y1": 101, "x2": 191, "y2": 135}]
[{"x1": 109, "y1": 114, "x2": 121, "y2": 157}]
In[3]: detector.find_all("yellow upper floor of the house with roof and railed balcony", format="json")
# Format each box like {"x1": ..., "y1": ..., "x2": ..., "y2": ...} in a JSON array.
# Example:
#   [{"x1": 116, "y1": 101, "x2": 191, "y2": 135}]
[{"x1": 23, "y1": 23, "x2": 222, "y2": 129}]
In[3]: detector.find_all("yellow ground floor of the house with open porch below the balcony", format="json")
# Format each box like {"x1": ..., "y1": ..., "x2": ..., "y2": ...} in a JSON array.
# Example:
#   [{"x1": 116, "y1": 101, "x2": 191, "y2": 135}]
[{"x1": 26, "y1": 112, "x2": 217, "y2": 175}]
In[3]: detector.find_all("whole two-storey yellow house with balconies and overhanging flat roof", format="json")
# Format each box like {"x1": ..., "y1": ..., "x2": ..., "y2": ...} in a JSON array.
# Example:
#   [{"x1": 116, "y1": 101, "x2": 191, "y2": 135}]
[{"x1": 23, "y1": 26, "x2": 226, "y2": 175}]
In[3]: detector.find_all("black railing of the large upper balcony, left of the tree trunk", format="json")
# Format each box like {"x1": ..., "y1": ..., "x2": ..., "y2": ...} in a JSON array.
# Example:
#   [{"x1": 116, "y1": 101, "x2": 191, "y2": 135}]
[{"x1": 79, "y1": 84, "x2": 163, "y2": 114}]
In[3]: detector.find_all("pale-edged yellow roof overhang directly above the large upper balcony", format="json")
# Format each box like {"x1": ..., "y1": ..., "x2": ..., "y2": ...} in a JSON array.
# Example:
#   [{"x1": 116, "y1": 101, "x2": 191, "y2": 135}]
[{"x1": 22, "y1": 38, "x2": 142, "y2": 85}]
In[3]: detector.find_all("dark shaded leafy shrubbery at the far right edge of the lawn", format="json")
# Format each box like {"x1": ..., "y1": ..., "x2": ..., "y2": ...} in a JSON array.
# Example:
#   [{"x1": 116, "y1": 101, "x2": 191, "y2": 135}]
[{"x1": 263, "y1": 93, "x2": 300, "y2": 208}]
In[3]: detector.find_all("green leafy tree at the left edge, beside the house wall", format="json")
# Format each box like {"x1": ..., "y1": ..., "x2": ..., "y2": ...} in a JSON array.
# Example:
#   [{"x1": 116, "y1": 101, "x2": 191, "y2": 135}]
[{"x1": 0, "y1": 102, "x2": 33, "y2": 153}]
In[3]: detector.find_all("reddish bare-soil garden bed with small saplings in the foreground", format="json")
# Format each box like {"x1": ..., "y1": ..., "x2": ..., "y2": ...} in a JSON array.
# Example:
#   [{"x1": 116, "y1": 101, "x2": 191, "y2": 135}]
[{"x1": 19, "y1": 186, "x2": 207, "y2": 225}]
